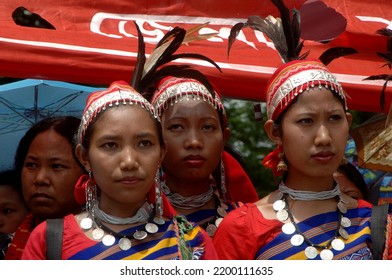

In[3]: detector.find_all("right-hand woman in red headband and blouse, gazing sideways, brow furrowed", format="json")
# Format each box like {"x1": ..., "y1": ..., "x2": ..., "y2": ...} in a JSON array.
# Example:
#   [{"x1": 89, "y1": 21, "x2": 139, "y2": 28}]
[{"x1": 214, "y1": 57, "x2": 372, "y2": 260}]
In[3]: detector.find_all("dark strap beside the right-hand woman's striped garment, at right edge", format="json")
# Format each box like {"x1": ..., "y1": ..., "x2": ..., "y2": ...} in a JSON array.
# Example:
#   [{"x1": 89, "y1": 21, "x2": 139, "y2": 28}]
[{"x1": 371, "y1": 203, "x2": 389, "y2": 260}]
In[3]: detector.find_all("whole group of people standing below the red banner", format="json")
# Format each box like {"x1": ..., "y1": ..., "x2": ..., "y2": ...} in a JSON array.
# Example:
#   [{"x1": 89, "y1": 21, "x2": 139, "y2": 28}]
[{"x1": 0, "y1": 1, "x2": 390, "y2": 260}]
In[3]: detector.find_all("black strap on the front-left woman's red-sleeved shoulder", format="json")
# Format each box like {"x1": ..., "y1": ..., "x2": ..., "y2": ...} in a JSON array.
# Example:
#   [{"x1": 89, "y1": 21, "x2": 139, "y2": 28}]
[{"x1": 46, "y1": 219, "x2": 64, "y2": 260}]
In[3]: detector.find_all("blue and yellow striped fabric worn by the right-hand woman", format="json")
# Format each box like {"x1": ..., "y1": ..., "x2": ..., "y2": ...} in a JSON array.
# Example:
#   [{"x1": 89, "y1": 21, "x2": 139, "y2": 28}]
[{"x1": 256, "y1": 208, "x2": 372, "y2": 260}]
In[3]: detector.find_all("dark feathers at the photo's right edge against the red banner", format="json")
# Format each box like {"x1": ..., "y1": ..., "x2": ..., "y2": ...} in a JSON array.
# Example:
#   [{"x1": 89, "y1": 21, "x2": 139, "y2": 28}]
[{"x1": 364, "y1": 28, "x2": 392, "y2": 122}]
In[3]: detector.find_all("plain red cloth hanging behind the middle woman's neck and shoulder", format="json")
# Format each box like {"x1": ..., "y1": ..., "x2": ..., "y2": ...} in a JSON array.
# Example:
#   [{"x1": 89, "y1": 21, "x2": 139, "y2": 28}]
[{"x1": 222, "y1": 151, "x2": 259, "y2": 203}]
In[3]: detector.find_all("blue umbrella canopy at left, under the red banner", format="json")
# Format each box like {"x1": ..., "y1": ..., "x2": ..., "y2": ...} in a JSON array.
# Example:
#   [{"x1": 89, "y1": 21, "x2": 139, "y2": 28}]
[{"x1": 0, "y1": 79, "x2": 104, "y2": 169}]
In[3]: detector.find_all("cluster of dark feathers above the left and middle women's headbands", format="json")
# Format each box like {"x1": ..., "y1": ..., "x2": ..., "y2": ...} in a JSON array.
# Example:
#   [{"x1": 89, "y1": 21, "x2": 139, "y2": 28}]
[{"x1": 131, "y1": 22, "x2": 222, "y2": 99}]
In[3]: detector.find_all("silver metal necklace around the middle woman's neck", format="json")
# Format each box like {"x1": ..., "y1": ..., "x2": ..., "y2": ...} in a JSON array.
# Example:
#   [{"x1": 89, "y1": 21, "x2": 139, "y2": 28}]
[{"x1": 161, "y1": 181, "x2": 214, "y2": 209}]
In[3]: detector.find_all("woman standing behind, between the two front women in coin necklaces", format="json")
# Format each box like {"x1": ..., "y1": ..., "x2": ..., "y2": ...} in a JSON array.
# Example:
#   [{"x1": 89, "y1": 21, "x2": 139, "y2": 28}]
[{"x1": 151, "y1": 77, "x2": 258, "y2": 236}]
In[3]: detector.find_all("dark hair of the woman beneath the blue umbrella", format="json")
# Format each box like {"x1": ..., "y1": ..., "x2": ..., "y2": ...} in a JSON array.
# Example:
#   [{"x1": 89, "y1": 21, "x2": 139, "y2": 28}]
[{"x1": 14, "y1": 116, "x2": 84, "y2": 174}]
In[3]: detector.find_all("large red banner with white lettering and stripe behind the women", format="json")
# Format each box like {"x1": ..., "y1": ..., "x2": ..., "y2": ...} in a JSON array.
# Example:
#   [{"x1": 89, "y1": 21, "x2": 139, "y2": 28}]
[{"x1": 0, "y1": 0, "x2": 392, "y2": 112}]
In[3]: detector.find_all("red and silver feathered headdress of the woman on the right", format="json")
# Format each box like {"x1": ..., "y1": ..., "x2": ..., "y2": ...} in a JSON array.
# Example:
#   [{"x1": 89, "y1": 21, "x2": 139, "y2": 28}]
[{"x1": 228, "y1": 0, "x2": 356, "y2": 176}]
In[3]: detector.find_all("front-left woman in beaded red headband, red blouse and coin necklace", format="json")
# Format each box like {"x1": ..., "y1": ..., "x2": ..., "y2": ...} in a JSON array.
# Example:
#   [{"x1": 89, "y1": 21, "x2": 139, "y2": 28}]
[{"x1": 22, "y1": 82, "x2": 216, "y2": 260}]
